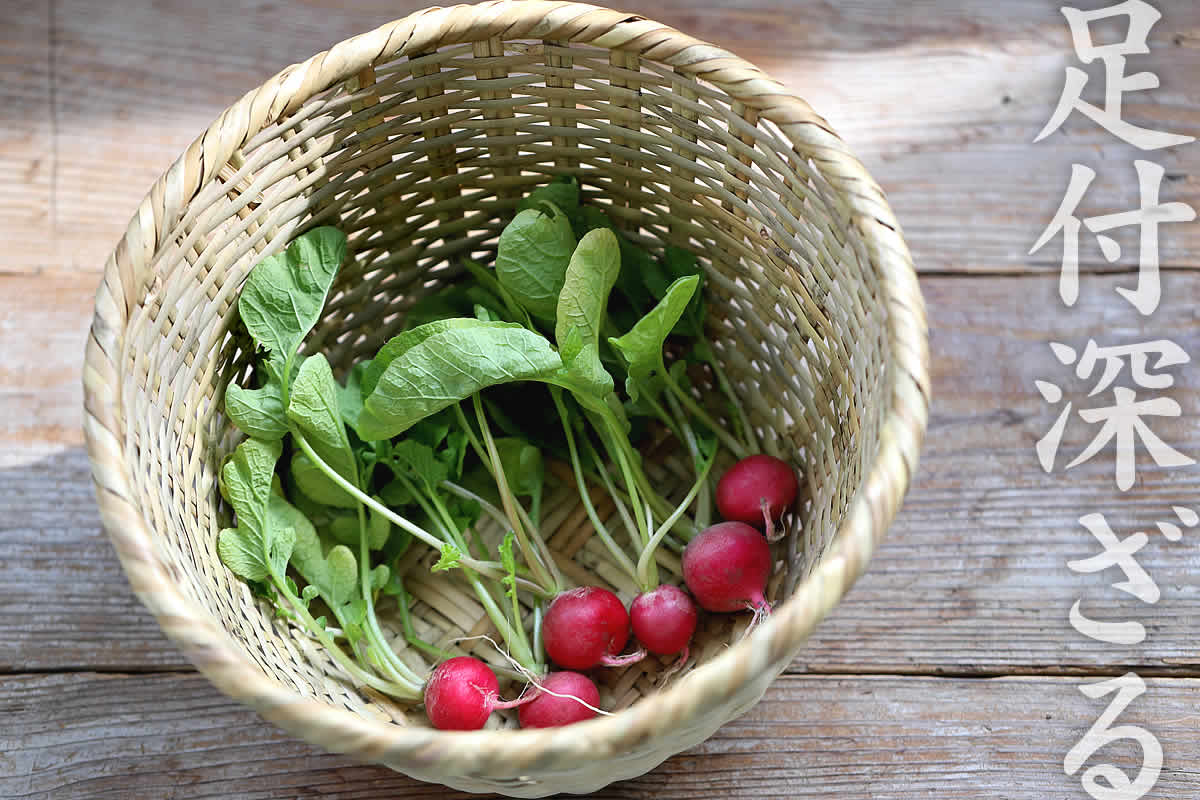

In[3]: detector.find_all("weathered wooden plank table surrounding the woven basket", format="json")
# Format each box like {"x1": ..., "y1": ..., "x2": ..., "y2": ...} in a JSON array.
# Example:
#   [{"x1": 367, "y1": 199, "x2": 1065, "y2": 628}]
[{"x1": 0, "y1": 0, "x2": 1200, "y2": 800}]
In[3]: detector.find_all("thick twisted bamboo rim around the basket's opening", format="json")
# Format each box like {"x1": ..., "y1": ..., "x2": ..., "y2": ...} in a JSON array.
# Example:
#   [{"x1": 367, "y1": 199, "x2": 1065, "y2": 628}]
[{"x1": 83, "y1": 0, "x2": 930, "y2": 781}]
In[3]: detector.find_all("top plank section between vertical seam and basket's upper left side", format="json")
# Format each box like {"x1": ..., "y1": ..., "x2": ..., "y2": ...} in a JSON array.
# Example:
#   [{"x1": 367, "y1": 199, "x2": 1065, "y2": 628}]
[{"x1": 56, "y1": 0, "x2": 441, "y2": 271}]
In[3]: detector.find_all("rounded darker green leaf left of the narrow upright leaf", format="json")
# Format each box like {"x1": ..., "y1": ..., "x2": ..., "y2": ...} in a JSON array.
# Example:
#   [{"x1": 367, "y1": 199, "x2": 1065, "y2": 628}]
[{"x1": 496, "y1": 203, "x2": 575, "y2": 319}]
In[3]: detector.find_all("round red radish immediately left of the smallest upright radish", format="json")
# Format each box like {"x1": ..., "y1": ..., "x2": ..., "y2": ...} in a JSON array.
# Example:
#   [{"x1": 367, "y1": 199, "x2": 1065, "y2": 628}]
[{"x1": 541, "y1": 587, "x2": 644, "y2": 669}]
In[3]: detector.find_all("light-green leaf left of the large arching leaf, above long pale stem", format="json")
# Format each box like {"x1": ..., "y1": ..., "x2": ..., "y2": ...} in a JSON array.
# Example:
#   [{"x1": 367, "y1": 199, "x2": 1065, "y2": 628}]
[{"x1": 288, "y1": 354, "x2": 358, "y2": 485}]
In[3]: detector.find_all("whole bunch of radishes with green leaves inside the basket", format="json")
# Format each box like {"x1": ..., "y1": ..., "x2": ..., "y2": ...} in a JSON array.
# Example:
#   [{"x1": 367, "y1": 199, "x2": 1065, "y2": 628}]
[{"x1": 216, "y1": 190, "x2": 797, "y2": 730}]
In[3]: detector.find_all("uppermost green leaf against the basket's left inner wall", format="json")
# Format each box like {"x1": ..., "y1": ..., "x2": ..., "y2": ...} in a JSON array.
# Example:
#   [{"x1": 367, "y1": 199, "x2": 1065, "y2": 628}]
[{"x1": 238, "y1": 227, "x2": 346, "y2": 357}]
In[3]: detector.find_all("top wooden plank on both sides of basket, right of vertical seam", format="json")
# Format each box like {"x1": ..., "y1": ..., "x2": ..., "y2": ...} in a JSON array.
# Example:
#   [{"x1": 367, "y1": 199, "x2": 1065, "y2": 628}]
[{"x1": 37, "y1": 0, "x2": 1200, "y2": 278}]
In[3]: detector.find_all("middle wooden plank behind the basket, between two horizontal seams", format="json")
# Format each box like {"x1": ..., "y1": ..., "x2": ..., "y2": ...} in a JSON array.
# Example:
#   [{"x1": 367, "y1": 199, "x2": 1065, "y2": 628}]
[{"x1": 7, "y1": 272, "x2": 1200, "y2": 674}]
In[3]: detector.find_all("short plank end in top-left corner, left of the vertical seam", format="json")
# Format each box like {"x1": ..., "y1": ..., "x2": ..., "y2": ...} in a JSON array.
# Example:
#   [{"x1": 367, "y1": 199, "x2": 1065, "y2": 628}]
[{"x1": 0, "y1": 0, "x2": 54, "y2": 271}]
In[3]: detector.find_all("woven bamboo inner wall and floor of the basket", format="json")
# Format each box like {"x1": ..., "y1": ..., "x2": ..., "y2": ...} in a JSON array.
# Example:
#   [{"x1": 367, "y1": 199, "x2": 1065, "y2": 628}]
[{"x1": 122, "y1": 38, "x2": 889, "y2": 726}]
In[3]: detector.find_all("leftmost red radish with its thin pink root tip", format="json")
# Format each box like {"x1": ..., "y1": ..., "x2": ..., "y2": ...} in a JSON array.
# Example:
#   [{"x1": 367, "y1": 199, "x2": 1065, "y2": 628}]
[{"x1": 425, "y1": 656, "x2": 534, "y2": 730}]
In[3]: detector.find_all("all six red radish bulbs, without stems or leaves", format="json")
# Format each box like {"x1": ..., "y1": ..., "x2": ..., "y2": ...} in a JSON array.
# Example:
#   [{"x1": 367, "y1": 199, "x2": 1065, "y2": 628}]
[{"x1": 425, "y1": 456, "x2": 798, "y2": 730}]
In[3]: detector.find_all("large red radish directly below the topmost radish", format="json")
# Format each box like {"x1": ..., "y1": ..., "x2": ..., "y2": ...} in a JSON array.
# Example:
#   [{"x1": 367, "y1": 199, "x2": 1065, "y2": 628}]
[{"x1": 683, "y1": 522, "x2": 772, "y2": 618}]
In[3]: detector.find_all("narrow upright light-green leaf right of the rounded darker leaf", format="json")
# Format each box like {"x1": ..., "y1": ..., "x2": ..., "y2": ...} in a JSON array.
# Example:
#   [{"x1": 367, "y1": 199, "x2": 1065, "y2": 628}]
[{"x1": 554, "y1": 228, "x2": 620, "y2": 395}]
